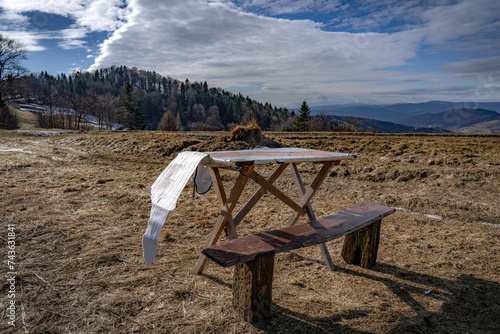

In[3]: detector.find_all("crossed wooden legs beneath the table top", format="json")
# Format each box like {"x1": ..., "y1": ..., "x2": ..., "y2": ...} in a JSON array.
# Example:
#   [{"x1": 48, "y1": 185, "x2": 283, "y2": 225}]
[{"x1": 194, "y1": 161, "x2": 335, "y2": 274}]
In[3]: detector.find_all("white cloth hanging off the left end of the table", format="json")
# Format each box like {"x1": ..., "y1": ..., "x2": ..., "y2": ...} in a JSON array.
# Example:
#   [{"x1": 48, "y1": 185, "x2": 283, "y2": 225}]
[{"x1": 142, "y1": 151, "x2": 208, "y2": 264}]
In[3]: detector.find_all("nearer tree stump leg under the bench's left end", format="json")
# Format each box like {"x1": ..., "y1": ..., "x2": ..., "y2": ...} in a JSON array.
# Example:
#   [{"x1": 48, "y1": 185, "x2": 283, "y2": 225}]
[{"x1": 233, "y1": 255, "x2": 274, "y2": 323}]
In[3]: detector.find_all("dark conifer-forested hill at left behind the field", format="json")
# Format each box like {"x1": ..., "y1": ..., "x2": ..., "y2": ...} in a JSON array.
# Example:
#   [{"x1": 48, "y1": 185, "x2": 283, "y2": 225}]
[{"x1": 20, "y1": 66, "x2": 289, "y2": 130}]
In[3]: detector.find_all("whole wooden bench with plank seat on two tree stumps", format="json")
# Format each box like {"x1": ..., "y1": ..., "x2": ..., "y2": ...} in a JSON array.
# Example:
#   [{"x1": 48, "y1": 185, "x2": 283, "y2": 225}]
[{"x1": 203, "y1": 202, "x2": 395, "y2": 322}]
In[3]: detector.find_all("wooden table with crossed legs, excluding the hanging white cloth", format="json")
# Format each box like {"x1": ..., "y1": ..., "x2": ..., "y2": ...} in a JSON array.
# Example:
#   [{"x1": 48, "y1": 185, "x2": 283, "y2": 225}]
[{"x1": 194, "y1": 147, "x2": 356, "y2": 274}]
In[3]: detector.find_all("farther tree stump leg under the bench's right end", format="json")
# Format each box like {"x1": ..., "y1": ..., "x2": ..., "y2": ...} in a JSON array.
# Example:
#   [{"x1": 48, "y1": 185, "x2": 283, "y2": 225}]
[{"x1": 342, "y1": 220, "x2": 381, "y2": 268}]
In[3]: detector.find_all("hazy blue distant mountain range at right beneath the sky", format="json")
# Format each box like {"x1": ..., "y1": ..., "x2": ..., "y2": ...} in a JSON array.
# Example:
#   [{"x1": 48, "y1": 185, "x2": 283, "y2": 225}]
[{"x1": 311, "y1": 101, "x2": 500, "y2": 133}]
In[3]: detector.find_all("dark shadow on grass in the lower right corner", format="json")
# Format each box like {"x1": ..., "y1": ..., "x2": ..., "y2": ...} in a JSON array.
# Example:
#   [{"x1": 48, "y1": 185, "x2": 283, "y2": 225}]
[{"x1": 337, "y1": 263, "x2": 500, "y2": 334}]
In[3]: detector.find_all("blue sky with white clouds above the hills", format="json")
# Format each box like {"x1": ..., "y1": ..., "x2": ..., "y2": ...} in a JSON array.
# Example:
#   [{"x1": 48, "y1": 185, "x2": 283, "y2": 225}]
[{"x1": 0, "y1": 0, "x2": 500, "y2": 107}]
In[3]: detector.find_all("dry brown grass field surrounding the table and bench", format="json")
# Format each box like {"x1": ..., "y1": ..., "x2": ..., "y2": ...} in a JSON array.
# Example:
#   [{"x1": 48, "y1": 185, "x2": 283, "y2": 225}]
[{"x1": 0, "y1": 130, "x2": 500, "y2": 333}]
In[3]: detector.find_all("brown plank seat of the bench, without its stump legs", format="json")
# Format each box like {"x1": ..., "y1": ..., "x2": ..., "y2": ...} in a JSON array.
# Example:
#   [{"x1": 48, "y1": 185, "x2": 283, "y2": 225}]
[{"x1": 203, "y1": 202, "x2": 395, "y2": 267}]
